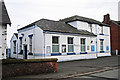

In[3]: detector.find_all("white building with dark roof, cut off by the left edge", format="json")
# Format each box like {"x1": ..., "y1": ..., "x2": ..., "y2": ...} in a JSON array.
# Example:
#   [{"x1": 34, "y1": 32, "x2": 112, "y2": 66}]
[{"x1": 0, "y1": 0, "x2": 11, "y2": 59}]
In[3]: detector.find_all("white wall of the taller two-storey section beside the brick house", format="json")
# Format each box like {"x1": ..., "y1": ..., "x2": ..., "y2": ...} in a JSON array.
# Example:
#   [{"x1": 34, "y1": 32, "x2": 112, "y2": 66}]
[{"x1": 69, "y1": 21, "x2": 111, "y2": 55}]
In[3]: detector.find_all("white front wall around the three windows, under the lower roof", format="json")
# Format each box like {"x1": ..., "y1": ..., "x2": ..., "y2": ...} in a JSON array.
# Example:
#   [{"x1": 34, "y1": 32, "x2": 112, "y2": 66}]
[{"x1": 45, "y1": 34, "x2": 96, "y2": 54}]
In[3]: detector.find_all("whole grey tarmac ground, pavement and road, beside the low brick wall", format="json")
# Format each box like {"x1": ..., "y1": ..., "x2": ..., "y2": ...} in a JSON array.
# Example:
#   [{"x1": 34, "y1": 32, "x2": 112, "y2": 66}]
[{"x1": 1, "y1": 56, "x2": 120, "y2": 80}]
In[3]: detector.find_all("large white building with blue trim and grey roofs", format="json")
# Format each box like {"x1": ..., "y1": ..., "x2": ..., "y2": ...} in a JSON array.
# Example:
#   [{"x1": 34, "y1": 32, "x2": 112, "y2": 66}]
[{"x1": 11, "y1": 16, "x2": 111, "y2": 61}]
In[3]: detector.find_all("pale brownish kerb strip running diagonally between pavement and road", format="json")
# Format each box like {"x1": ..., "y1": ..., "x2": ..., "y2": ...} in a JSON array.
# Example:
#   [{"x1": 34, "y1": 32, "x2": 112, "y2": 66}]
[{"x1": 63, "y1": 66, "x2": 120, "y2": 79}]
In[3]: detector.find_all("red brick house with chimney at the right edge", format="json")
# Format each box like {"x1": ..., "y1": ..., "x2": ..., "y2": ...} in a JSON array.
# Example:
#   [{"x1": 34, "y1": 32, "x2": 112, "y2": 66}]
[{"x1": 103, "y1": 14, "x2": 120, "y2": 55}]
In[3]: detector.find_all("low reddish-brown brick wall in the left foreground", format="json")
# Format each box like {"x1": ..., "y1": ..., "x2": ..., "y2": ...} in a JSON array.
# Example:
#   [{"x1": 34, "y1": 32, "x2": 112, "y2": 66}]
[{"x1": 2, "y1": 58, "x2": 57, "y2": 78}]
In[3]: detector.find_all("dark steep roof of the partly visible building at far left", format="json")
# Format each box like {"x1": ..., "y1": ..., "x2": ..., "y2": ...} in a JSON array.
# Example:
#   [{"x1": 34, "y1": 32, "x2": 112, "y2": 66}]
[{"x1": 0, "y1": 0, "x2": 11, "y2": 24}]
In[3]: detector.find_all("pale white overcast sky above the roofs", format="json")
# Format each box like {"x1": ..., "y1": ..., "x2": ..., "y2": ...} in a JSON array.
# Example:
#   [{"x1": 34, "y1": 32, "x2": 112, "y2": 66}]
[{"x1": 4, "y1": 0, "x2": 120, "y2": 47}]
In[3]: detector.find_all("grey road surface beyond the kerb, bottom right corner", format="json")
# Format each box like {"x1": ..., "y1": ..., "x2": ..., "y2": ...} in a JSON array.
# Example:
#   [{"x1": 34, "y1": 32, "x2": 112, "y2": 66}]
[{"x1": 64, "y1": 69, "x2": 120, "y2": 80}]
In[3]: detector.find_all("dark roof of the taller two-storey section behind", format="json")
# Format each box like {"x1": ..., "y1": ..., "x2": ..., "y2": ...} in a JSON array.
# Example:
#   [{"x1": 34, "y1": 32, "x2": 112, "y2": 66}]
[{"x1": 60, "y1": 15, "x2": 110, "y2": 27}]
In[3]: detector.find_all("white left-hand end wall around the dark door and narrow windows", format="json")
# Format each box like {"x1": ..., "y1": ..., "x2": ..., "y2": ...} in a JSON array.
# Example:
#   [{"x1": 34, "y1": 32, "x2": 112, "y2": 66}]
[{"x1": 18, "y1": 26, "x2": 44, "y2": 59}]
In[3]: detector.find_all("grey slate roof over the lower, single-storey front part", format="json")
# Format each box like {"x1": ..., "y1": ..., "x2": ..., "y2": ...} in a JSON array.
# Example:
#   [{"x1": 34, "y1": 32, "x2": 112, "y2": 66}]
[{"x1": 18, "y1": 19, "x2": 96, "y2": 36}]
